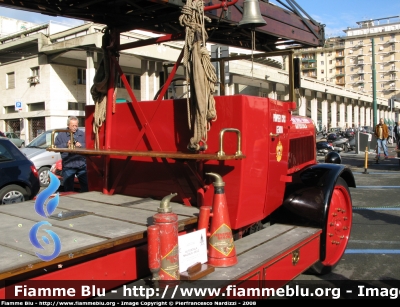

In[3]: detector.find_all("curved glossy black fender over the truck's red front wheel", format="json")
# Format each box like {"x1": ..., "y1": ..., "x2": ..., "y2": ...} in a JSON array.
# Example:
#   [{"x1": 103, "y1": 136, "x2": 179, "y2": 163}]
[{"x1": 283, "y1": 163, "x2": 356, "y2": 261}]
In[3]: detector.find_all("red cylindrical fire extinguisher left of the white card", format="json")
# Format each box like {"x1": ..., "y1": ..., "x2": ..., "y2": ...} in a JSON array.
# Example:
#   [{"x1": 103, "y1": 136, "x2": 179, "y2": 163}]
[{"x1": 149, "y1": 193, "x2": 179, "y2": 280}]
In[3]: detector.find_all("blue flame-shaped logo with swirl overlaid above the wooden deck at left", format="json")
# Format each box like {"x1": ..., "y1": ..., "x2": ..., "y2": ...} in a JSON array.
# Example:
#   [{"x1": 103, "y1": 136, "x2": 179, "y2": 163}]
[{"x1": 29, "y1": 172, "x2": 61, "y2": 261}]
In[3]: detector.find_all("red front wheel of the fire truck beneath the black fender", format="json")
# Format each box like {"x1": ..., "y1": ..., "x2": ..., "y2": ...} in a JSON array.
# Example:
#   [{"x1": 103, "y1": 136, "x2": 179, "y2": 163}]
[{"x1": 310, "y1": 177, "x2": 353, "y2": 275}]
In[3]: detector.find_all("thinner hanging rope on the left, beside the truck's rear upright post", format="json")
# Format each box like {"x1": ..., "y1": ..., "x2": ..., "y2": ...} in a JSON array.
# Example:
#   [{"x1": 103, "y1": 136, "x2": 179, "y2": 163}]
[{"x1": 90, "y1": 27, "x2": 110, "y2": 149}]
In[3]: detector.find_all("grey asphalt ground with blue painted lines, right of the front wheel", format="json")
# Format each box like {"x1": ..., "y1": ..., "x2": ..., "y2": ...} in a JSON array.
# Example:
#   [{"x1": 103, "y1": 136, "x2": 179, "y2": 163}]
[{"x1": 291, "y1": 146, "x2": 400, "y2": 298}]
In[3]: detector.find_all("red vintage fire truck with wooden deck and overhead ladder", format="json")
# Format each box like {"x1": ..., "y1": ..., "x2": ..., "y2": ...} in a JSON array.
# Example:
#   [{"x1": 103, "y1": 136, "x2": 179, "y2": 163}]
[{"x1": 0, "y1": 0, "x2": 355, "y2": 297}]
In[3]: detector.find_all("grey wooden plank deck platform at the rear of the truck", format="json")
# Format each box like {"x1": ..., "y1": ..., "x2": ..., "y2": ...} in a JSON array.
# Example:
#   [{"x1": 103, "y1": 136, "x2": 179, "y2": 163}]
[{"x1": 0, "y1": 192, "x2": 199, "y2": 280}]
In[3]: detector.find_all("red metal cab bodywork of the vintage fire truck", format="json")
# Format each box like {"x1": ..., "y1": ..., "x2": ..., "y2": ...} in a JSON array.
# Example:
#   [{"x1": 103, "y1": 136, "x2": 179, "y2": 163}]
[{"x1": 86, "y1": 95, "x2": 314, "y2": 229}]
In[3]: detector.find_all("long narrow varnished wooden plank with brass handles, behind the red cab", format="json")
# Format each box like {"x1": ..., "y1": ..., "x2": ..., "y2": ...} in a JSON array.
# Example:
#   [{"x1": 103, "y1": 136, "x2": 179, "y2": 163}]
[{"x1": 47, "y1": 148, "x2": 246, "y2": 160}]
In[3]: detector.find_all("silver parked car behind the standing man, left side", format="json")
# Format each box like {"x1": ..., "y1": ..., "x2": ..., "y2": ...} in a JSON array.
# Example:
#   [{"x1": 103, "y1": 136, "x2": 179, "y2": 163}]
[{"x1": 21, "y1": 127, "x2": 85, "y2": 187}]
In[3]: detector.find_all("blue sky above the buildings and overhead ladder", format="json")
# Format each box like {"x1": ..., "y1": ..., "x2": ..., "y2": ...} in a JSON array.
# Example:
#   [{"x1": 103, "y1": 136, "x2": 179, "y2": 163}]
[{"x1": 0, "y1": 0, "x2": 400, "y2": 37}]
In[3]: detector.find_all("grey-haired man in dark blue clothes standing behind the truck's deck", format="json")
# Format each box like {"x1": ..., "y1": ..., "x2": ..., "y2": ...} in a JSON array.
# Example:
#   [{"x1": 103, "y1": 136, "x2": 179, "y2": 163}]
[{"x1": 54, "y1": 116, "x2": 88, "y2": 192}]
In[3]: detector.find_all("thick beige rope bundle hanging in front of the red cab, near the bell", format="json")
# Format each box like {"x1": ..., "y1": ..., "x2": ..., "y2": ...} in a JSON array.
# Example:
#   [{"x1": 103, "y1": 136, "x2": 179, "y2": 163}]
[{"x1": 179, "y1": 0, "x2": 217, "y2": 151}]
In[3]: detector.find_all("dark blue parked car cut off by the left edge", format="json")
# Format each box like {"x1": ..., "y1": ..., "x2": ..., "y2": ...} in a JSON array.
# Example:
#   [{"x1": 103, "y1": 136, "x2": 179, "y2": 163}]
[{"x1": 0, "y1": 137, "x2": 40, "y2": 205}]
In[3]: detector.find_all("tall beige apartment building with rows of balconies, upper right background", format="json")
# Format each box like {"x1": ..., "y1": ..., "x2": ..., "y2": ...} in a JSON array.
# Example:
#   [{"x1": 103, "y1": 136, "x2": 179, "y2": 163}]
[{"x1": 295, "y1": 16, "x2": 400, "y2": 101}]
